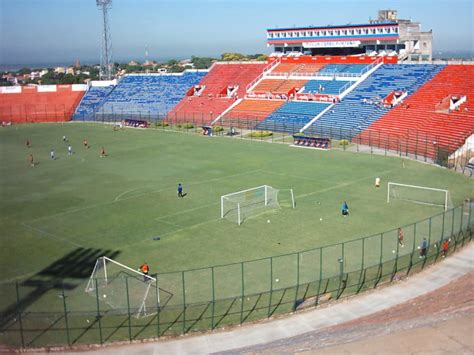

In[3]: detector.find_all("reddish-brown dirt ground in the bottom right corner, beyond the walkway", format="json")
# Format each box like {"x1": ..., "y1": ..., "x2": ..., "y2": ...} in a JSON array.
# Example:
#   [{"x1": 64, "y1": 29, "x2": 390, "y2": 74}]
[{"x1": 224, "y1": 272, "x2": 474, "y2": 354}]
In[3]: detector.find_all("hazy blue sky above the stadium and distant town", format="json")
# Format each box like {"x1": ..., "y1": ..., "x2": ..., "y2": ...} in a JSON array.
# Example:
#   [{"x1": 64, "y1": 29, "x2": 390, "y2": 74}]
[{"x1": 0, "y1": 0, "x2": 474, "y2": 64}]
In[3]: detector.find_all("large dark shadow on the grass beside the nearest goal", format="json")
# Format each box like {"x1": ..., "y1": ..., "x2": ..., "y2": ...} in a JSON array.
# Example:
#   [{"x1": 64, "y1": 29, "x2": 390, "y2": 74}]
[{"x1": 0, "y1": 248, "x2": 120, "y2": 340}]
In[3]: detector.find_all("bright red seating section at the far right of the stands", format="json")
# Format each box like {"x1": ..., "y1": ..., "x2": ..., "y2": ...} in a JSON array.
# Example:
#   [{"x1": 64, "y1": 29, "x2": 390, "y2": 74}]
[{"x1": 358, "y1": 65, "x2": 474, "y2": 156}]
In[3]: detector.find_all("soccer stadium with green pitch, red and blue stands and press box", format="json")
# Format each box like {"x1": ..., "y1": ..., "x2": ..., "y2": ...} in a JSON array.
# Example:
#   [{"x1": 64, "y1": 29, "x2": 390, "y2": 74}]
[{"x1": 0, "y1": 0, "x2": 474, "y2": 353}]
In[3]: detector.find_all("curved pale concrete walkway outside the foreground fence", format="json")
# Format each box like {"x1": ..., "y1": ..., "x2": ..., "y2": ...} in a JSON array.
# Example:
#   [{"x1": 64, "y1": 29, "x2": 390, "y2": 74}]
[{"x1": 75, "y1": 243, "x2": 474, "y2": 355}]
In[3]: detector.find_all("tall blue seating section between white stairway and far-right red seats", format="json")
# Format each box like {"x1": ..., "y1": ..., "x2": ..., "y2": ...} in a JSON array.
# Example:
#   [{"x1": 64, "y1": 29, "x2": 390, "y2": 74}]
[{"x1": 305, "y1": 64, "x2": 443, "y2": 139}]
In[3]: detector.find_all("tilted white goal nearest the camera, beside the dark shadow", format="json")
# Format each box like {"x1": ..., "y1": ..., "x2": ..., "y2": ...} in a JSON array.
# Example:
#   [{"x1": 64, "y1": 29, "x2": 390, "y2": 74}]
[{"x1": 85, "y1": 256, "x2": 160, "y2": 318}]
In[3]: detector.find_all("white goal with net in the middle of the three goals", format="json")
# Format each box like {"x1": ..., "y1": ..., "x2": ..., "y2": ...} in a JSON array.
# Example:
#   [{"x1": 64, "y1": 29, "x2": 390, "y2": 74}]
[{"x1": 221, "y1": 185, "x2": 295, "y2": 225}]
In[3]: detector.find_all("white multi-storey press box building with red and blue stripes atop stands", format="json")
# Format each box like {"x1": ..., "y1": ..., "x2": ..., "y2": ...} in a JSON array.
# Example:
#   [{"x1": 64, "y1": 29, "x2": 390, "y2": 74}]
[{"x1": 267, "y1": 10, "x2": 433, "y2": 61}]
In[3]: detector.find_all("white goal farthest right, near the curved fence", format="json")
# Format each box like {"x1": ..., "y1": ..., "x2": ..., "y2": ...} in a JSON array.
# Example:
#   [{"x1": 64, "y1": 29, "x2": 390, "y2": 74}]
[{"x1": 387, "y1": 182, "x2": 453, "y2": 211}]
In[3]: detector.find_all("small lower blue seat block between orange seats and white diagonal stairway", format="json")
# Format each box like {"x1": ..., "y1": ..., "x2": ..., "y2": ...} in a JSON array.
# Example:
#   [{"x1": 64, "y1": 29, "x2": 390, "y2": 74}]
[{"x1": 257, "y1": 101, "x2": 330, "y2": 133}]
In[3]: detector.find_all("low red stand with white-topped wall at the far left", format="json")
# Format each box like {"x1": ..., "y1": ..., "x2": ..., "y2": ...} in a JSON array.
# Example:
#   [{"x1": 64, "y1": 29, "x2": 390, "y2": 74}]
[{"x1": 0, "y1": 85, "x2": 86, "y2": 123}]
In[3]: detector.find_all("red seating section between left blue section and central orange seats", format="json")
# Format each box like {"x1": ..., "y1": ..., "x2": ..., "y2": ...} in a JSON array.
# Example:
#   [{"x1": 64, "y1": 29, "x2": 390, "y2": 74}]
[{"x1": 168, "y1": 62, "x2": 267, "y2": 123}]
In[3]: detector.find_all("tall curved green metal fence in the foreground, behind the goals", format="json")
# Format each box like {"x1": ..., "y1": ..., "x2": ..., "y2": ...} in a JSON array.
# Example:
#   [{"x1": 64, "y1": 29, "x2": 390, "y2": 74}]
[{"x1": 0, "y1": 202, "x2": 474, "y2": 348}]
